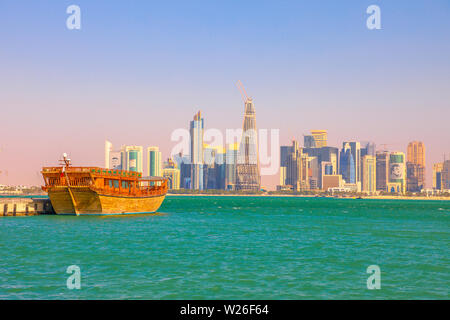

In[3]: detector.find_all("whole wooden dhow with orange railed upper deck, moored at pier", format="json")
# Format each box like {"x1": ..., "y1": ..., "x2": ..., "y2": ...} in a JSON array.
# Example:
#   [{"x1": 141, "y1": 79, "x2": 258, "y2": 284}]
[{"x1": 42, "y1": 154, "x2": 167, "y2": 215}]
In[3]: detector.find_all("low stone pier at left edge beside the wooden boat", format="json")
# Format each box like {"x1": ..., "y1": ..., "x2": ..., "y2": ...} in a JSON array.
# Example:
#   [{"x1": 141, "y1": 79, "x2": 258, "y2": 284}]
[{"x1": 0, "y1": 198, "x2": 55, "y2": 216}]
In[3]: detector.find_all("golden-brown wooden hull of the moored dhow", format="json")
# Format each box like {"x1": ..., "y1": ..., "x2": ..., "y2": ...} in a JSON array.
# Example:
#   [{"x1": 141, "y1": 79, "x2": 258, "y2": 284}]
[{"x1": 48, "y1": 187, "x2": 165, "y2": 215}]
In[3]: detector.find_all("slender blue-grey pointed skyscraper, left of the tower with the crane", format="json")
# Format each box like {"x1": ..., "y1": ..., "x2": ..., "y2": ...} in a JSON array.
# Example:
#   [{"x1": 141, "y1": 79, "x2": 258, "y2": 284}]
[{"x1": 190, "y1": 111, "x2": 204, "y2": 190}]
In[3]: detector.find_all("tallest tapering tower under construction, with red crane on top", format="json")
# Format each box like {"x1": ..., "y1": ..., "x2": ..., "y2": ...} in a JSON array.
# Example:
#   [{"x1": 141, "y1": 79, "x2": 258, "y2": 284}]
[{"x1": 236, "y1": 81, "x2": 261, "y2": 191}]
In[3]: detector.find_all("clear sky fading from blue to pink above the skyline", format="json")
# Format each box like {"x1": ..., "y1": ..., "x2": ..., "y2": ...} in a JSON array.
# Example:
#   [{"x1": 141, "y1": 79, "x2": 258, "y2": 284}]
[{"x1": 0, "y1": 0, "x2": 450, "y2": 187}]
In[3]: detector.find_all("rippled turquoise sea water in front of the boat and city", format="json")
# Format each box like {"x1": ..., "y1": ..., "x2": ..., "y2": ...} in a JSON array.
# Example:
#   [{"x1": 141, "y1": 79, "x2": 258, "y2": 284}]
[{"x1": 0, "y1": 196, "x2": 450, "y2": 299}]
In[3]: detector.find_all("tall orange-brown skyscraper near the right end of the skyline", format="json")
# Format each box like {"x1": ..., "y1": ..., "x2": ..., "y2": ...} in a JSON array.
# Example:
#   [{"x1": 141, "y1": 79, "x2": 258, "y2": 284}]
[{"x1": 406, "y1": 141, "x2": 425, "y2": 192}]
